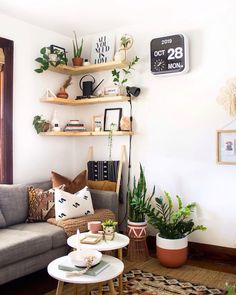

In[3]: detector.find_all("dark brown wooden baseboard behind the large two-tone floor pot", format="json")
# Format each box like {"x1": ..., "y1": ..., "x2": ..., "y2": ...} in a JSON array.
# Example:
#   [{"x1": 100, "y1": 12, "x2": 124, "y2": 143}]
[{"x1": 147, "y1": 236, "x2": 236, "y2": 265}]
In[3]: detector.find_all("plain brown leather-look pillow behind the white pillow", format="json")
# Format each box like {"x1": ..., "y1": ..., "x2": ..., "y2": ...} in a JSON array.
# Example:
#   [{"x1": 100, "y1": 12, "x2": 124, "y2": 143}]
[{"x1": 51, "y1": 170, "x2": 87, "y2": 194}]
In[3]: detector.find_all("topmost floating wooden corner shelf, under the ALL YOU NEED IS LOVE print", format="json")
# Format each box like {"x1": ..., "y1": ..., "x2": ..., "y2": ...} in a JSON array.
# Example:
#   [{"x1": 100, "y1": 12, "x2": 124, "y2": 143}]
[{"x1": 49, "y1": 61, "x2": 128, "y2": 75}]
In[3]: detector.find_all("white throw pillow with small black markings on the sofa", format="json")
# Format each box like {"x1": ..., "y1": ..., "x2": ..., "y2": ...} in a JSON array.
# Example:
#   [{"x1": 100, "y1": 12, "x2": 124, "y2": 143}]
[{"x1": 55, "y1": 186, "x2": 94, "y2": 220}]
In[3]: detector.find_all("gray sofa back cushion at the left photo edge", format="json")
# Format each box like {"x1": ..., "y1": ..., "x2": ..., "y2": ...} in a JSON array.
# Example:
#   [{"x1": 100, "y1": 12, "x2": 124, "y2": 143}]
[{"x1": 0, "y1": 184, "x2": 28, "y2": 226}]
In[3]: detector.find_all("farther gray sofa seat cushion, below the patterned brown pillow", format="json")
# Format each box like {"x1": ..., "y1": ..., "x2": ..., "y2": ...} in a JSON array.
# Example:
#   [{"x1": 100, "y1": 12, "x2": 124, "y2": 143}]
[{"x1": 9, "y1": 222, "x2": 67, "y2": 248}]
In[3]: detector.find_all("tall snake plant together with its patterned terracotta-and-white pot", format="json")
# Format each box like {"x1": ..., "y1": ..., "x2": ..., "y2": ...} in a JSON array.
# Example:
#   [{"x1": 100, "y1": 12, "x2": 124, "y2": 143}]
[{"x1": 128, "y1": 164, "x2": 155, "y2": 238}]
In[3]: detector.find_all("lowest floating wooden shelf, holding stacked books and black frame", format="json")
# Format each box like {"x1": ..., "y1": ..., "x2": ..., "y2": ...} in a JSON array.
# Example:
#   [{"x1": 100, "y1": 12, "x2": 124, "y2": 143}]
[{"x1": 40, "y1": 131, "x2": 134, "y2": 136}]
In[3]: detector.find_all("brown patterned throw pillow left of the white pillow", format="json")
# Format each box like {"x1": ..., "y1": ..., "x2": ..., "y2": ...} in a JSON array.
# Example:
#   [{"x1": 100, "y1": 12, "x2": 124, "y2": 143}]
[{"x1": 27, "y1": 186, "x2": 55, "y2": 222}]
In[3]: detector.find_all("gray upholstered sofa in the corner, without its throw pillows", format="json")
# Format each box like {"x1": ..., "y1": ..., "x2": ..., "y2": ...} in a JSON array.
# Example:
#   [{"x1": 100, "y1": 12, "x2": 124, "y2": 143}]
[{"x1": 0, "y1": 181, "x2": 118, "y2": 285}]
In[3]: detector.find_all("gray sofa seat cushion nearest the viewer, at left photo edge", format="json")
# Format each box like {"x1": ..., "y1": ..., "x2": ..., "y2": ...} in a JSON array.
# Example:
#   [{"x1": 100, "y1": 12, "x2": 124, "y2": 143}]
[{"x1": 0, "y1": 229, "x2": 52, "y2": 267}]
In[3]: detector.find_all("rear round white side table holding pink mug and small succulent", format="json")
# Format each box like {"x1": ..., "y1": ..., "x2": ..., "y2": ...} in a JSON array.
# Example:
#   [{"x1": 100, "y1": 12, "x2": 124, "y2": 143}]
[{"x1": 67, "y1": 233, "x2": 129, "y2": 295}]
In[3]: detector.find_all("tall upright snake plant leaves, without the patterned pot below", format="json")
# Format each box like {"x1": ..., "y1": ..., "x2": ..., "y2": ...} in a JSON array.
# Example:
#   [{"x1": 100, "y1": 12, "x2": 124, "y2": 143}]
[{"x1": 128, "y1": 164, "x2": 155, "y2": 222}]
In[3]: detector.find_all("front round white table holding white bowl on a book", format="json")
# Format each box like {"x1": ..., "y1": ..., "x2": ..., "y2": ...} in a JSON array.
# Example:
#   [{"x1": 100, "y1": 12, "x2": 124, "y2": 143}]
[{"x1": 48, "y1": 255, "x2": 124, "y2": 295}]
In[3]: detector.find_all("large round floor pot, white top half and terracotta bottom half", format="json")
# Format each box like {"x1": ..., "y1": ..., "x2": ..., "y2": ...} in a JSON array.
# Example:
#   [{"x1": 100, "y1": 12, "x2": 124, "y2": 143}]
[{"x1": 156, "y1": 234, "x2": 188, "y2": 268}]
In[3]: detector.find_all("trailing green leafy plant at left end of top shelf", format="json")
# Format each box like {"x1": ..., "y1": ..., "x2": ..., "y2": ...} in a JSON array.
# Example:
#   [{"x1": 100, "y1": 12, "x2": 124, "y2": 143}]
[{"x1": 34, "y1": 47, "x2": 67, "y2": 73}]
